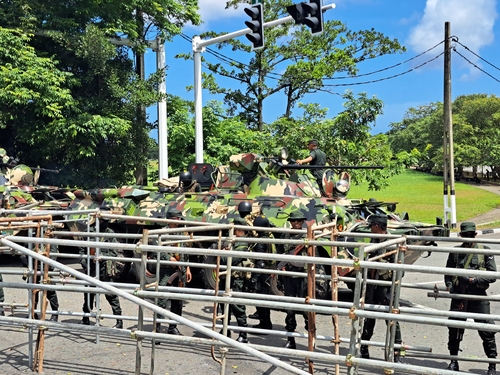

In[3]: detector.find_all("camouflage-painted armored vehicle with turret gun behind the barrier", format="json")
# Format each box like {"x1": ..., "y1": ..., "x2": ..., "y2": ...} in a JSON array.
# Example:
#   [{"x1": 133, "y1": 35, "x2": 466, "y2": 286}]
[{"x1": 63, "y1": 149, "x2": 450, "y2": 290}]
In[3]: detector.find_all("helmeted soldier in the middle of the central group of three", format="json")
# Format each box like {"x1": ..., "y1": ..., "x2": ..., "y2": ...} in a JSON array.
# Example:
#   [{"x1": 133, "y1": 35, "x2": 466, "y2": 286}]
[{"x1": 252, "y1": 216, "x2": 274, "y2": 329}]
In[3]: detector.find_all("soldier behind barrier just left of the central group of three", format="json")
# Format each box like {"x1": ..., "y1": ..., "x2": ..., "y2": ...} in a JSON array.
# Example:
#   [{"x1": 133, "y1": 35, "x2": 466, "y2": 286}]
[{"x1": 152, "y1": 209, "x2": 192, "y2": 344}]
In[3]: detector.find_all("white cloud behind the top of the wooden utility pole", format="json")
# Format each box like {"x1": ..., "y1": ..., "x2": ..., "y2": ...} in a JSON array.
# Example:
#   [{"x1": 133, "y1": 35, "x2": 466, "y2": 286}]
[{"x1": 407, "y1": 0, "x2": 498, "y2": 73}]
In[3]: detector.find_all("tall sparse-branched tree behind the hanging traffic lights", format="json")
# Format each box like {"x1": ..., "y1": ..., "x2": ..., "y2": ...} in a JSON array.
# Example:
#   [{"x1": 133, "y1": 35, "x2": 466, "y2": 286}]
[{"x1": 183, "y1": 0, "x2": 404, "y2": 130}]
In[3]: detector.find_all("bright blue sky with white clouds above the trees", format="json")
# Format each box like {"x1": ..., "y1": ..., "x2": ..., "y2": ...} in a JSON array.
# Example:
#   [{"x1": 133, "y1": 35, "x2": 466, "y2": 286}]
[{"x1": 146, "y1": 0, "x2": 500, "y2": 134}]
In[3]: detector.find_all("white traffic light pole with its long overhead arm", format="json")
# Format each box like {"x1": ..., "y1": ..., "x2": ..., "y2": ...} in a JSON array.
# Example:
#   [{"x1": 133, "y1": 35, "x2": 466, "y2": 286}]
[{"x1": 192, "y1": 4, "x2": 335, "y2": 163}]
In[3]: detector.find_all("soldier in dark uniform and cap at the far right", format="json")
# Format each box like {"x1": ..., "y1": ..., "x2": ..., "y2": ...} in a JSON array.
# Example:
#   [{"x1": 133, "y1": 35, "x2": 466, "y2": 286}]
[{"x1": 444, "y1": 222, "x2": 497, "y2": 375}]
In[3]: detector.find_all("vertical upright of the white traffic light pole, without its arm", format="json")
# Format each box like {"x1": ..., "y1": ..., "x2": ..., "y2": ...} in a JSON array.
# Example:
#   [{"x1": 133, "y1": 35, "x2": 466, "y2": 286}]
[{"x1": 193, "y1": 36, "x2": 204, "y2": 163}]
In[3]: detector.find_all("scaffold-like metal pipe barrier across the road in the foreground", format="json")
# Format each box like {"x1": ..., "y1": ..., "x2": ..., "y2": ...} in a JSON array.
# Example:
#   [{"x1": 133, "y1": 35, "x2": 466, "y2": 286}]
[{"x1": 0, "y1": 210, "x2": 500, "y2": 375}]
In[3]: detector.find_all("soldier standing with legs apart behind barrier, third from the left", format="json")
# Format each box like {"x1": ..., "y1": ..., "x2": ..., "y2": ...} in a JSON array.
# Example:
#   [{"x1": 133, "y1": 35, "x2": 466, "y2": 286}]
[{"x1": 80, "y1": 218, "x2": 123, "y2": 329}]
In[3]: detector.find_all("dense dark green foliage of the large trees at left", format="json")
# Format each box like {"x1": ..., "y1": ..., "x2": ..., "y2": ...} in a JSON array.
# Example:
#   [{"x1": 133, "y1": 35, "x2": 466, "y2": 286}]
[{"x1": 0, "y1": 0, "x2": 200, "y2": 187}]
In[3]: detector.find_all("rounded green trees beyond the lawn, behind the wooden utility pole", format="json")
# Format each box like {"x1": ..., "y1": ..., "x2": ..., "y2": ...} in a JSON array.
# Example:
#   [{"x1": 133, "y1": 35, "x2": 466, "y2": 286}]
[{"x1": 388, "y1": 94, "x2": 500, "y2": 176}]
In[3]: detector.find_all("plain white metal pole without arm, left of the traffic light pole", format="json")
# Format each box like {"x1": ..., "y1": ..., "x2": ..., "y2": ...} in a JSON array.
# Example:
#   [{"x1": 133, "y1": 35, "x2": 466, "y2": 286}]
[{"x1": 156, "y1": 37, "x2": 168, "y2": 180}]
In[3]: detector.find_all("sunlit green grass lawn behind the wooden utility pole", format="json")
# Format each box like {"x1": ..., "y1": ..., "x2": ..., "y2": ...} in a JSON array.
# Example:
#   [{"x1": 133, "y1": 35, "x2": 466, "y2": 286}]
[{"x1": 348, "y1": 170, "x2": 500, "y2": 223}]
